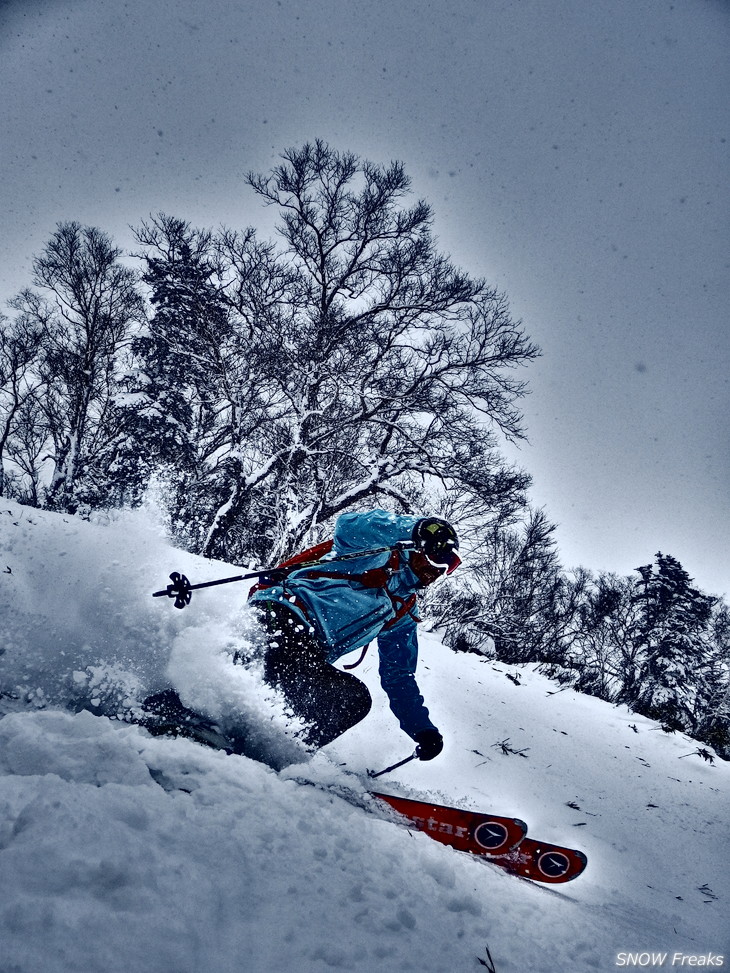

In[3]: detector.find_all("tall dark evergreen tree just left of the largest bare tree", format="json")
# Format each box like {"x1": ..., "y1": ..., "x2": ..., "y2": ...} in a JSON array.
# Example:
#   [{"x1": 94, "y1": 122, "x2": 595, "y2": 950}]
[{"x1": 122, "y1": 214, "x2": 226, "y2": 528}]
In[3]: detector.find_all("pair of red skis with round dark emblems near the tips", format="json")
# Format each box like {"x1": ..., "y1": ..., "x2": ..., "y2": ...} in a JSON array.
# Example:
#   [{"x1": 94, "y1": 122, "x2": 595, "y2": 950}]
[{"x1": 373, "y1": 794, "x2": 588, "y2": 884}]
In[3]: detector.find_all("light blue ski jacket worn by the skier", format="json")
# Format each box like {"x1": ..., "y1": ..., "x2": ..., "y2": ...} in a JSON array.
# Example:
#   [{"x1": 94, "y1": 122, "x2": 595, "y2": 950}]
[{"x1": 251, "y1": 510, "x2": 435, "y2": 738}]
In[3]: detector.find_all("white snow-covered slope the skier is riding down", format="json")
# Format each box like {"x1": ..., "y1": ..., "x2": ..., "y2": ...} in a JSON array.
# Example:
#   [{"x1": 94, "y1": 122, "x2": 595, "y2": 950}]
[{"x1": 0, "y1": 501, "x2": 730, "y2": 973}]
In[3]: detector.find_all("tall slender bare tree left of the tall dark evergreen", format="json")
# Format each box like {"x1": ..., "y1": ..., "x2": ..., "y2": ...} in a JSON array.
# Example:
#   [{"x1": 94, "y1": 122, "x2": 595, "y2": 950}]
[{"x1": 12, "y1": 222, "x2": 144, "y2": 511}]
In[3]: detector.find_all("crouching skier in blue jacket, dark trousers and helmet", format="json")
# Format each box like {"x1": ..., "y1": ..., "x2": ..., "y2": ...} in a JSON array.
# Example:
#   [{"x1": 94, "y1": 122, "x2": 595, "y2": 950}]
[{"x1": 250, "y1": 510, "x2": 460, "y2": 760}]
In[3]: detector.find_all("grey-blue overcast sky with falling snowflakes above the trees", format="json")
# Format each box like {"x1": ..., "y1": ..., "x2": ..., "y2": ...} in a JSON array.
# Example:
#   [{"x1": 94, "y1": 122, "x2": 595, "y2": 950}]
[{"x1": 0, "y1": 0, "x2": 730, "y2": 595}]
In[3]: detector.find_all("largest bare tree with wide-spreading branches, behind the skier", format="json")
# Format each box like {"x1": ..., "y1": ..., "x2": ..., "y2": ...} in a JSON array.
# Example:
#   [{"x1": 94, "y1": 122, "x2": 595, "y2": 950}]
[{"x1": 193, "y1": 142, "x2": 537, "y2": 557}]
